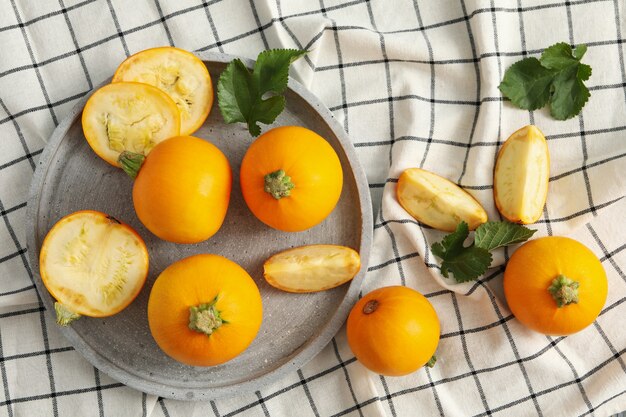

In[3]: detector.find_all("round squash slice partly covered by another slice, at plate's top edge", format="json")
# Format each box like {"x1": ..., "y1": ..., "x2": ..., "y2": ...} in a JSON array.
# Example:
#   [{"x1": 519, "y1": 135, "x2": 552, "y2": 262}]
[{"x1": 113, "y1": 46, "x2": 213, "y2": 136}]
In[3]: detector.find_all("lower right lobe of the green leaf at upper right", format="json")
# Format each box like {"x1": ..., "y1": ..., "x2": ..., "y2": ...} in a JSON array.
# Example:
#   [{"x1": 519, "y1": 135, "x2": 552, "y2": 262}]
[{"x1": 550, "y1": 66, "x2": 591, "y2": 120}]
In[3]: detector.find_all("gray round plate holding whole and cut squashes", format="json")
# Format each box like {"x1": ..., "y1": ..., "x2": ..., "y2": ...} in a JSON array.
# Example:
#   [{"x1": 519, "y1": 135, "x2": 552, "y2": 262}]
[{"x1": 27, "y1": 53, "x2": 372, "y2": 400}]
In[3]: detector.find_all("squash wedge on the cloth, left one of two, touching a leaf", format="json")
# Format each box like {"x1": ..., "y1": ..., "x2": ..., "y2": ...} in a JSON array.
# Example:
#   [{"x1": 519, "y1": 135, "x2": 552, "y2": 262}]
[{"x1": 396, "y1": 168, "x2": 487, "y2": 232}]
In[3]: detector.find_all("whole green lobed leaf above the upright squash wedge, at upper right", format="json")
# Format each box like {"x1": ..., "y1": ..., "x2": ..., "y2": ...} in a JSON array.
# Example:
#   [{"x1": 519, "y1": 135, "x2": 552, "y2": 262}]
[{"x1": 499, "y1": 42, "x2": 591, "y2": 120}]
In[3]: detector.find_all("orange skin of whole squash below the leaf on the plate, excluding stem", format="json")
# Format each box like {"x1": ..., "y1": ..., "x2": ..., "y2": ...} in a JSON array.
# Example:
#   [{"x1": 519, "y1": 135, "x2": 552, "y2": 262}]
[{"x1": 240, "y1": 126, "x2": 343, "y2": 232}]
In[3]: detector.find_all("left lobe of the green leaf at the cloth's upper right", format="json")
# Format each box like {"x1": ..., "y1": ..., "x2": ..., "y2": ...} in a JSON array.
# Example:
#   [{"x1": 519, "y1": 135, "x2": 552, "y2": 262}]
[{"x1": 498, "y1": 58, "x2": 554, "y2": 110}]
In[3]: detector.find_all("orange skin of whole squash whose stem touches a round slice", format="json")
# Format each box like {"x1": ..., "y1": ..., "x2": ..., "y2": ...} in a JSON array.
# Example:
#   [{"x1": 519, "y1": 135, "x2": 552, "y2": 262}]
[{"x1": 133, "y1": 136, "x2": 232, "y2": 243}]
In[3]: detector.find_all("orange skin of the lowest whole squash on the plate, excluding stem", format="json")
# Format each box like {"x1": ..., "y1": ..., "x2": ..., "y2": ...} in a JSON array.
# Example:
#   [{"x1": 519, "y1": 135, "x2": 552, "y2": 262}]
[{"x1": 148, "y1": 254, "x2": 263, "y2": 366}]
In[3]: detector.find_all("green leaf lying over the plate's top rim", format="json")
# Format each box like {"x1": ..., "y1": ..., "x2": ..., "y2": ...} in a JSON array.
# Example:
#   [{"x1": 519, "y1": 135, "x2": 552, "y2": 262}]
[{"x1": 217, "y1": 49, "x2": 307, "y2": 136}]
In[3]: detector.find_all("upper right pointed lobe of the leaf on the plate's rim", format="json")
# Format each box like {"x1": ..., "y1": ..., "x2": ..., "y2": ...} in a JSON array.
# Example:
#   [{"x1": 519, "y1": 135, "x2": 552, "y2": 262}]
[{"x1": 253, "y1": 49, "x2": 307, "y2": 95}]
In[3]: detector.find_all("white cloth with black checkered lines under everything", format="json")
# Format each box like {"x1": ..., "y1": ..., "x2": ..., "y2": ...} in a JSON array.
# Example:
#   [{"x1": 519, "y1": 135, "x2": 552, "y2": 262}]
[{"x1": 0, "y1": 0, "x2": 626, "y2": 417}]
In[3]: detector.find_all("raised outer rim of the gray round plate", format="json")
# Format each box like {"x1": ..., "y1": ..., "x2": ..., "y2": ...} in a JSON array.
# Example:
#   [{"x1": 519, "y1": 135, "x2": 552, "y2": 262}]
[{"x1": 25, "y1": 51, "x2": 373, "y2": 401}]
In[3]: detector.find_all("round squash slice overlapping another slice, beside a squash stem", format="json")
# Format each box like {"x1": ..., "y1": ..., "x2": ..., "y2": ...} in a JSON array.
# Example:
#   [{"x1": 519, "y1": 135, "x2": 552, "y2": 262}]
[{"x1": 82, "y1": 83, "x2": 180, "y2": 167}]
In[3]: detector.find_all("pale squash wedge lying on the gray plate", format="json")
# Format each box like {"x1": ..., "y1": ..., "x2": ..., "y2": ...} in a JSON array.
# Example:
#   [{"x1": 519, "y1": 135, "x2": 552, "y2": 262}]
[{"x1": 263, "y1": 245, "x2": 361, "y2": 292}]
